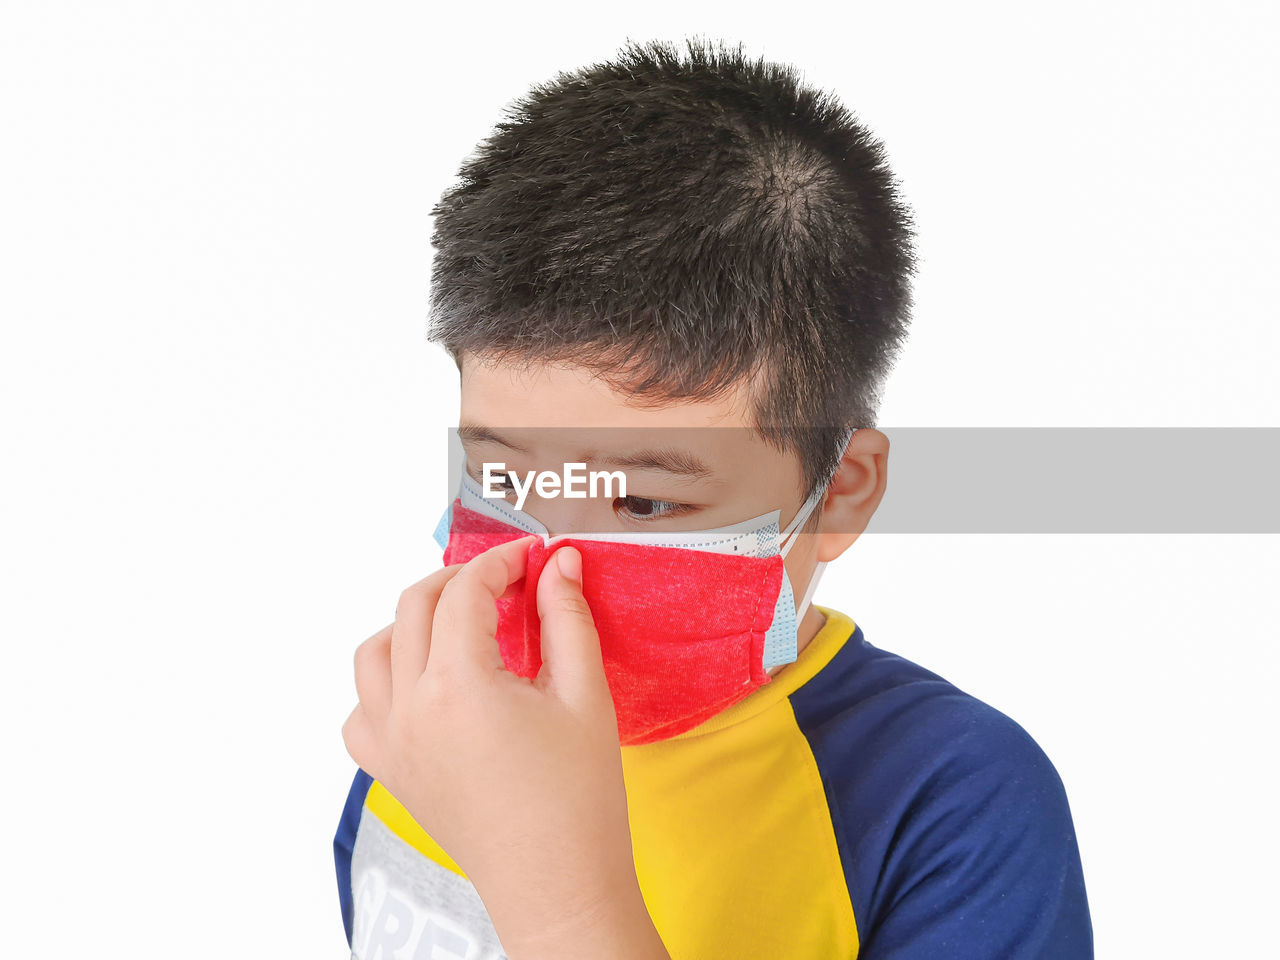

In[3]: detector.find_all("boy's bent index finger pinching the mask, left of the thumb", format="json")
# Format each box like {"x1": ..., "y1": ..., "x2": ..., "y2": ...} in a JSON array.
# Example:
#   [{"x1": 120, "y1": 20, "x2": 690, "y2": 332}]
[{"x1": 428, "y1": 536, "x2": 538, "y2": 677}]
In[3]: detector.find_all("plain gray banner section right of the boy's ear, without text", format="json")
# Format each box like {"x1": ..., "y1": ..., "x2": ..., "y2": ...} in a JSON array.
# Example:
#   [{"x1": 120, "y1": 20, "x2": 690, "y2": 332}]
[{"x1": 868, "y1": 428, "x2": 1280, "y2": 534}]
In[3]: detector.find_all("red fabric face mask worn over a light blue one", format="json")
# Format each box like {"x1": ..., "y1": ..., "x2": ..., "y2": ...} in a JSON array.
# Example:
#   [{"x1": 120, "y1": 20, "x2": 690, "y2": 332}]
[{"x1": 442, "y1": 499, "x2": 795, "y2": 745}]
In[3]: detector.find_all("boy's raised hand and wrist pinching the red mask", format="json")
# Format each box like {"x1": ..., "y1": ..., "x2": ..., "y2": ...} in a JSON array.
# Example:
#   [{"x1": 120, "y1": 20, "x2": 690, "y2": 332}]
[{"x1": 342, "y1": 538, "x2": 667, "y2": 960}]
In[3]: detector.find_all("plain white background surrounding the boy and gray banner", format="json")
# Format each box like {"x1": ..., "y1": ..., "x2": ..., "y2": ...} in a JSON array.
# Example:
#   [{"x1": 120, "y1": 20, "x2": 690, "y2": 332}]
[{"x1": 0, "y1": 0, "x2": 1280, "y2": 959}]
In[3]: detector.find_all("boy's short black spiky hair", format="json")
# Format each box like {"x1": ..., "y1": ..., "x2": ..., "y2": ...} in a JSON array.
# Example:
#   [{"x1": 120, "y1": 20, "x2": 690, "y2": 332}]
[{"x1": 430, "y1": 40, "x2": 916, "y2": 499}]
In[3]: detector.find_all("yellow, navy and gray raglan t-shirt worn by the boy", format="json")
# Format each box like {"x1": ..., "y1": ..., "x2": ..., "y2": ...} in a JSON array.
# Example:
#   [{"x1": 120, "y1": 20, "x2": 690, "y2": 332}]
[{"x1": 334, "y1": 607, "x2": 1093, "y2": 960}]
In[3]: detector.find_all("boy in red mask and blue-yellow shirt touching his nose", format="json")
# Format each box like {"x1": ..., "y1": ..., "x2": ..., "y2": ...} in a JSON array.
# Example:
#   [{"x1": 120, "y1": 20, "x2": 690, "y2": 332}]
[{"x1": 334, "y1": 44, "x2": 1092, "y2": 960}]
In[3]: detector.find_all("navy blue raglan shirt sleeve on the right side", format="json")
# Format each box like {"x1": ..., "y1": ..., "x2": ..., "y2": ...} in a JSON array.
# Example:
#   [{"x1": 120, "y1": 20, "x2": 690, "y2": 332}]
[{"x1": 791, "y1": 630, "x2": 1092, "y2": 957}]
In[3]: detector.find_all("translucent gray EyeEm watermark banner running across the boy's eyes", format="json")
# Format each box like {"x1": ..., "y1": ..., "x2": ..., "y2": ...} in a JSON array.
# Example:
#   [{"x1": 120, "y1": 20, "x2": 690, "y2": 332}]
[{"x1": 442, "y1": 424, "x2": 1280, "y2": 534}]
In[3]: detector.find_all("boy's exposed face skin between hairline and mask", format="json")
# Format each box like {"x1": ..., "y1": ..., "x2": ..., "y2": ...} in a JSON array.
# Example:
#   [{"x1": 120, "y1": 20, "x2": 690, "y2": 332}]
[{"x1": 458, "y1": 355, "x2": 817, "y2": 655}]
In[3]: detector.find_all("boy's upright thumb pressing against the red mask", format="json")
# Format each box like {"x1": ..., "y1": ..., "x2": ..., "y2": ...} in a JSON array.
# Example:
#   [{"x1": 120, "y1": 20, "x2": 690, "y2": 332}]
[{"x1": 538, "y1": 547, "x2": 612, "y2": 707}]
